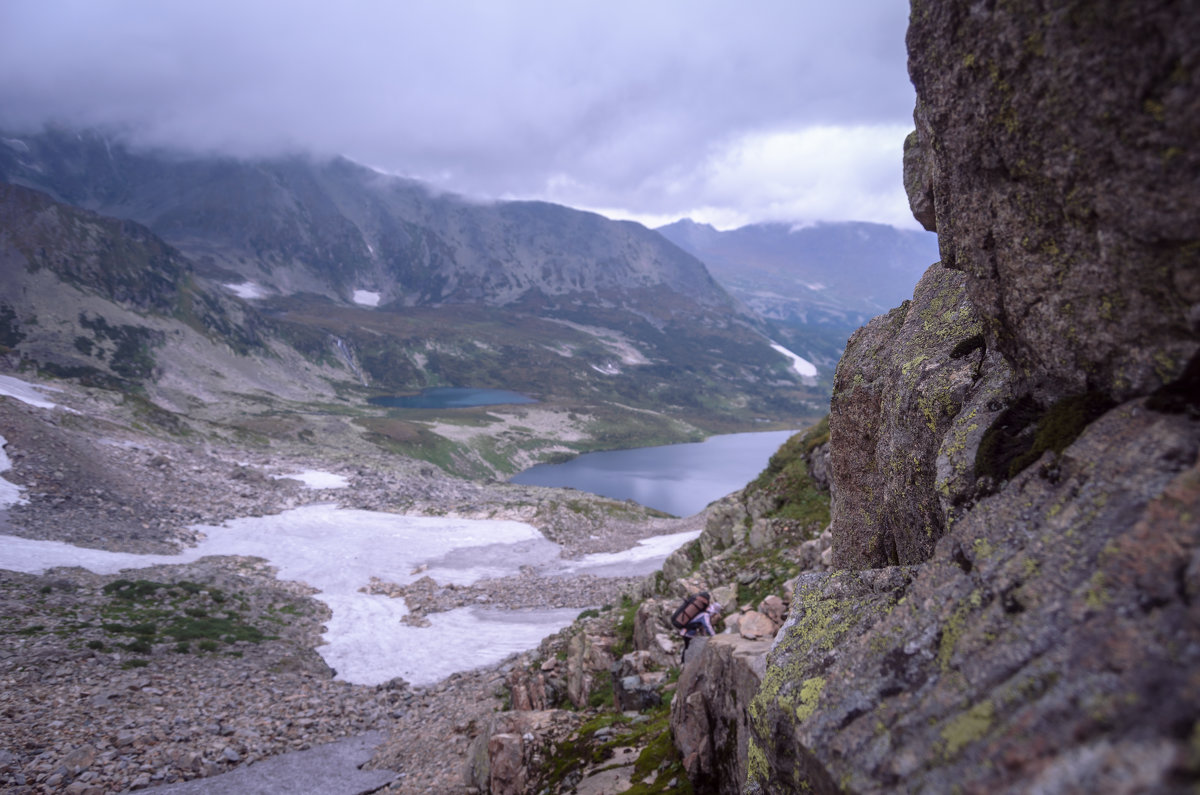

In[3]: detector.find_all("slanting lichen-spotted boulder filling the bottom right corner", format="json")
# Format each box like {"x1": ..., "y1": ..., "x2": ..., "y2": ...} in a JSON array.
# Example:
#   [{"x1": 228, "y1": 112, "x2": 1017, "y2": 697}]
[{"x1": 751, "y1": 401, "x2": 1200, "y2": 793}]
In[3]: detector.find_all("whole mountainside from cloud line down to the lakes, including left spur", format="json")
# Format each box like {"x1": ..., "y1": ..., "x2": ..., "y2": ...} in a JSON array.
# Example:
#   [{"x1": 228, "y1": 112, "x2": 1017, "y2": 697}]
[{"x1": 0, "y1": 130, "x2": 832, "y2": 474}]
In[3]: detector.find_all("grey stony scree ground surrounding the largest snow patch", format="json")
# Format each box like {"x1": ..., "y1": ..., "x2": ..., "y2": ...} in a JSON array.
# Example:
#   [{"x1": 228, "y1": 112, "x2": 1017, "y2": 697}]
[{"x1": 0, "y1": 377, "x2": 703, "y2": 793}]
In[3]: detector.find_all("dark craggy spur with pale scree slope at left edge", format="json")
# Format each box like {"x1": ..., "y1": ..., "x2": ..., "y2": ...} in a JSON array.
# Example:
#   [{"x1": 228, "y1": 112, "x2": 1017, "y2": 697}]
[{"x1": 0, "y1": 183, "x2": 337, "y2": 405}]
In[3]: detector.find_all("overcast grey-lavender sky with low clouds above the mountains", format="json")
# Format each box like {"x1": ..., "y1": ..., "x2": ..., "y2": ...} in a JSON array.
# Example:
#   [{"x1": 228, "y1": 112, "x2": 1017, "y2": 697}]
[{"x1": 0, "y1": 0, "x2": 916, "y2": 228}]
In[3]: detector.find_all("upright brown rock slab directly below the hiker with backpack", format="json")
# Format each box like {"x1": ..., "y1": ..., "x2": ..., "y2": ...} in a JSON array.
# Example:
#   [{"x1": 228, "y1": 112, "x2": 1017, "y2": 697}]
[{"x1": 671, "y1": 634, "x2": 770, "y2": 793}]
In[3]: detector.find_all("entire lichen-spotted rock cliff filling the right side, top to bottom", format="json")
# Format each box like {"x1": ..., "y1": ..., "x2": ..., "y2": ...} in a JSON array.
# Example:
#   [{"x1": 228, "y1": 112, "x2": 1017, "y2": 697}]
[{"x1": 748, "y1": 0, "x2": 1200, "y2": 793}]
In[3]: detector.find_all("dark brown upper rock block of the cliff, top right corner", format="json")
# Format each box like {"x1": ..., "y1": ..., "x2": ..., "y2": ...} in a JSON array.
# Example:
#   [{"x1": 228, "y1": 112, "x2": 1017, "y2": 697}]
[{"x1": 906, "y1": 0, "x2": 1200, "y2": 401}]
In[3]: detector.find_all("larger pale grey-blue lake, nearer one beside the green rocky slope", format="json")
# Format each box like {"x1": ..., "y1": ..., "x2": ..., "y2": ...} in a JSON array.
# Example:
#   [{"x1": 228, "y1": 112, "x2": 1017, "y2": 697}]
[{"x1": 511, "y1": 431, "x2": 796, "y2": 516}]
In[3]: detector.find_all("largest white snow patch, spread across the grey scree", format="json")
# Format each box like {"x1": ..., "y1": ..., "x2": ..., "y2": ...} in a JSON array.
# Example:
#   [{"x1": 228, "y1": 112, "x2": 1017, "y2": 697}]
[{"x1": 0, "y1": 504, "x2": 695, "y2": 686}]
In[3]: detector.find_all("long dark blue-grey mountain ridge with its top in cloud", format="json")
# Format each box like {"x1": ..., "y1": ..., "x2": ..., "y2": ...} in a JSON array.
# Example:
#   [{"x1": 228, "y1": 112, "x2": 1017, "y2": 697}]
[{"x1": 0, "y1": 130, "x2": 729, "y2": 324}]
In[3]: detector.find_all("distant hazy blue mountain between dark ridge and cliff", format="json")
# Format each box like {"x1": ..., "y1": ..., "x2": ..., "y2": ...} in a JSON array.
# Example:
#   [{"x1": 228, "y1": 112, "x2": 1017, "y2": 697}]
[{"x1": 658, "y1": 219, "x2": 938, "y2": 330}]
